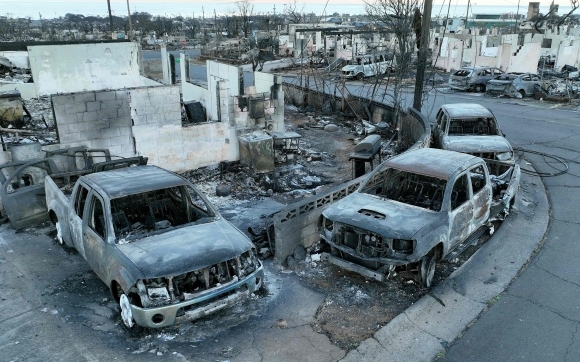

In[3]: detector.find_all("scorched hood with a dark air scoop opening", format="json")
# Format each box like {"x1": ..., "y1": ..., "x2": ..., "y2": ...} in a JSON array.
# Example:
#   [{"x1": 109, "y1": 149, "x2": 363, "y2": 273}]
[{"x1": 322, "y1": 192, "x2": 438, "y2": 240}]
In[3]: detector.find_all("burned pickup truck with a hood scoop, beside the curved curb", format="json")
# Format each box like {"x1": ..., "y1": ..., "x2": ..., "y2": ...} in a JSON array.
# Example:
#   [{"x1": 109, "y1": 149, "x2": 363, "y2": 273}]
[{"x1": 318, "y1": 148, "x2": 513, "y2": 287}]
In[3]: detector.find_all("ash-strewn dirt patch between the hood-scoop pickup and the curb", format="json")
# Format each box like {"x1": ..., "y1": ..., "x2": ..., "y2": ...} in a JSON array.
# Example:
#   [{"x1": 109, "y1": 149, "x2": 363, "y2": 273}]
[{"x1": 291, "y1": 222, "x2": 500, "y2": 350}]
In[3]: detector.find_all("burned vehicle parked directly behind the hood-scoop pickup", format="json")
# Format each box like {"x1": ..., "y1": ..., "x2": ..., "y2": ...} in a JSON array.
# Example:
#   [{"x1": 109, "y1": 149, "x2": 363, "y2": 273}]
[{"x1": 431, "y1": 103, "x2": 521, "y2": 218}]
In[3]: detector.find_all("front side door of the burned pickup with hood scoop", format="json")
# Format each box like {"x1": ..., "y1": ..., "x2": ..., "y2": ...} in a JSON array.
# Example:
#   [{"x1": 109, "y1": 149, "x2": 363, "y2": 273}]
[{"x1": 449, "y1": 172, "x2": 474, "y2": 248}]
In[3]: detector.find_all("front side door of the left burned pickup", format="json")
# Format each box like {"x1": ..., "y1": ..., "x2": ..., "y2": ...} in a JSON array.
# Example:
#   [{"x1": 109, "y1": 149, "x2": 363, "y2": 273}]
[{"x1": 83, "y1": 190, "x2": 113, "y2": 281}]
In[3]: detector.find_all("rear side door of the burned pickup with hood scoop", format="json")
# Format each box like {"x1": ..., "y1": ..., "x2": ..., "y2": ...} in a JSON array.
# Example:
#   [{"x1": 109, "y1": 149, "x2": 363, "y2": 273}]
[{"x1": 468, "y1": 164, "x2": 491, "y2": 226}]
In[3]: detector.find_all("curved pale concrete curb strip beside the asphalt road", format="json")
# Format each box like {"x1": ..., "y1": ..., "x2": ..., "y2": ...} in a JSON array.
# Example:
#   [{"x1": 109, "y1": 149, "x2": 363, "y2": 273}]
[{"x1": 341, "y1": 166, "x2": 550, "y2": 362}]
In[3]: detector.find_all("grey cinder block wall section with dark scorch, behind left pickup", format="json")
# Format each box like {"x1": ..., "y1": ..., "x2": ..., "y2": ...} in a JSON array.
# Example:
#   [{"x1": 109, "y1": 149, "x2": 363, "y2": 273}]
[{"x1": 51, "y1": 90, "x2": 135, "y2": 157}]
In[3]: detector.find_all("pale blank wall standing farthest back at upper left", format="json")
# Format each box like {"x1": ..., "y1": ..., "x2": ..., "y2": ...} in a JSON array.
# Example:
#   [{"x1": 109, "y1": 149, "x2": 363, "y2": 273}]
[{"x1": 28, "y1": 42, "x2": 151, "y2": 95}]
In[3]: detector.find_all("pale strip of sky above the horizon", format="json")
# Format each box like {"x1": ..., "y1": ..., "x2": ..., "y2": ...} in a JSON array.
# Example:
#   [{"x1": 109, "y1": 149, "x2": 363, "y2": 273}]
[{"x1": 0, "y1": 0, "x2": 570, "y2": 19}]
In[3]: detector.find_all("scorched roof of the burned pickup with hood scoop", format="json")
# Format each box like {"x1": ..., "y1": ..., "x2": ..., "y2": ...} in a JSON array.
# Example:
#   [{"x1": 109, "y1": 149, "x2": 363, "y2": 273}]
[{"x1": 383, "y1": 148, "x2": 478, "y2": 180}]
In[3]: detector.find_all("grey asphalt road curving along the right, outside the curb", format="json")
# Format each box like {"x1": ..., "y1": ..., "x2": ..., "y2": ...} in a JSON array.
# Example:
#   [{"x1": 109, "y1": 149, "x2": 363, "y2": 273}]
[{"x1": 432, "y1": 95, "x2": 580, "y2": 361}]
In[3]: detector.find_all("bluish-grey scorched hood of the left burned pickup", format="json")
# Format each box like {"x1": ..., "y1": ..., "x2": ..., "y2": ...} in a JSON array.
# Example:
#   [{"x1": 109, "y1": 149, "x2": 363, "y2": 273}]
[{"x1": 117, "y1": 219, "x2": 252, "y2": 278}]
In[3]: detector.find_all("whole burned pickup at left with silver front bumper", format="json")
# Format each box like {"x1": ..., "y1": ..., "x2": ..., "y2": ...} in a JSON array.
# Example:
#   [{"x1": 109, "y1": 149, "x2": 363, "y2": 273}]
[{"x1": 45, "y1": 166, "x2": 264, "y2": 328}]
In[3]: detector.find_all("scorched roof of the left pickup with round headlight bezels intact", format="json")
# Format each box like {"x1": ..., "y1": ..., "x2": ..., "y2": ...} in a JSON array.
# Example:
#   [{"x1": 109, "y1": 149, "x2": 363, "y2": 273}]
[{"x1": 83, "y1": 165, "x2": 187, "y2": 199}]
